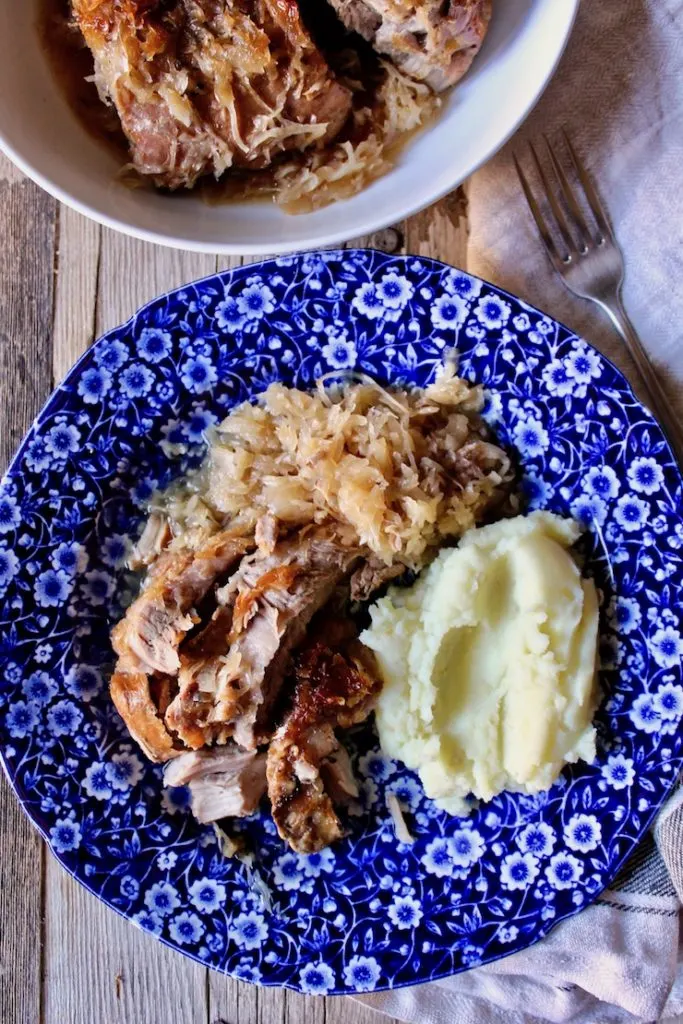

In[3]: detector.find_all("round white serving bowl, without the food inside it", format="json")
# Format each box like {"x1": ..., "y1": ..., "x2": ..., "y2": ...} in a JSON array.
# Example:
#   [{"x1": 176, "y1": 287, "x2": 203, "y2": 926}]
[{"x1": 0, "y1": 0, "x2": 580, "y2": 255}]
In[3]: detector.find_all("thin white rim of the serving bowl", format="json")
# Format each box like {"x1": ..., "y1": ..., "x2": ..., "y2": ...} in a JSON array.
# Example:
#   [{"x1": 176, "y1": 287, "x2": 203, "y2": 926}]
[{"x1": 0, "y1": 0, "x2": 581, "y2": 257}]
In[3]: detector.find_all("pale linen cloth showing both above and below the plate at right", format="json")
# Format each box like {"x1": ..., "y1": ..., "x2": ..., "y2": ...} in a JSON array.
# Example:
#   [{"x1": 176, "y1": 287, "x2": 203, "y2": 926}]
[{"x1": 356, "y1": 0, "x2": 683, "y2": 1024}]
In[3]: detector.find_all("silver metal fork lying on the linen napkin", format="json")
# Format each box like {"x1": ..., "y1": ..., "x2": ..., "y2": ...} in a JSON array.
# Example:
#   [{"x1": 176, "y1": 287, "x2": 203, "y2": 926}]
[{"x1": 513, "y1": 132, "x2": 683, "y2": 460}]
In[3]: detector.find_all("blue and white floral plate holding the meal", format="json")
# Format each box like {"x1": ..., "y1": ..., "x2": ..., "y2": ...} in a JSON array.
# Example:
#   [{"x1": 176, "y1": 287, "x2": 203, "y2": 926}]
[{"x1": 0, "y1": 251, "x2": 683, "y2": 993}]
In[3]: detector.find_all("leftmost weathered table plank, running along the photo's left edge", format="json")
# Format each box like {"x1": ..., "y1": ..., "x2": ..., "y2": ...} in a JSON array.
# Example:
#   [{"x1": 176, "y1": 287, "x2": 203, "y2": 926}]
[{"x1": 0, "y1": 151, "x2": 56, "y2": 1024}]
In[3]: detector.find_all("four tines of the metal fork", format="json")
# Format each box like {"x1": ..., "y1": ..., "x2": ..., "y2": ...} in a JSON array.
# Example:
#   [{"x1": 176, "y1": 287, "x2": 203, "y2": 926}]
[{"x1": 513, "y1": 130, "x2": 612, "y2": 266}]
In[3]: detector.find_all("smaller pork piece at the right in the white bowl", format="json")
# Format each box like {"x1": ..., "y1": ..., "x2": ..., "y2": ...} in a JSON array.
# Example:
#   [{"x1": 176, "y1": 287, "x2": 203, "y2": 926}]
[{"x1": 330, "y1": 0, "x2": 492, "y2": 92}]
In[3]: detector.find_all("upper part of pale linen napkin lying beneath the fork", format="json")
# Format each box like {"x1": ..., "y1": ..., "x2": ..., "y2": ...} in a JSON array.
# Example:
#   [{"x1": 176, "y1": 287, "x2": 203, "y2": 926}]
[{"x1": 467, "y1": 0, "x2": 683, "y2": 414}]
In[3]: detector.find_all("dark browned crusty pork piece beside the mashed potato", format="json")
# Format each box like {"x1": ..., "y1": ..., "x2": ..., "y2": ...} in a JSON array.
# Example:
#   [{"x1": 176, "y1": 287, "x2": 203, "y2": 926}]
[{"x1": 267, "y1": 642, "x2": 381, "y2": 853}]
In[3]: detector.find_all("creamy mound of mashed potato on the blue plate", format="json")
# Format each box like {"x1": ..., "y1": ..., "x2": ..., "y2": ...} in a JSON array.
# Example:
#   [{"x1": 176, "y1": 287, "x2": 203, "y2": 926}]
[{"x1": 361, "y1": 512, "x2": 598, "y2": 814}]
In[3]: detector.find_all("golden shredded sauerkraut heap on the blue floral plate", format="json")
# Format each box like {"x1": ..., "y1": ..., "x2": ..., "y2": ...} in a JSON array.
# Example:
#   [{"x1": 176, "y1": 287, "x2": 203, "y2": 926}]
[{"x1": 155, "y1": 368, "x2": 513, "y2": 568}]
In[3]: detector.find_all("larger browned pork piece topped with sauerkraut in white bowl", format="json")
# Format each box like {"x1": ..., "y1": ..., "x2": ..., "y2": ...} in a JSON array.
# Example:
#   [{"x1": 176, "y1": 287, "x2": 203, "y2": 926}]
[{"x1": 72, "y1": 0, "x2": 351, "y2": 188}]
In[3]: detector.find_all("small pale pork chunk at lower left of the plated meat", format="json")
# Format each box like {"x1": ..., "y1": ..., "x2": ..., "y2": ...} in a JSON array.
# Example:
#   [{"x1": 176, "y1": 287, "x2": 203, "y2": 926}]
[{"x1": 164, "y1": 743, "x2": 266, "y2": 822}]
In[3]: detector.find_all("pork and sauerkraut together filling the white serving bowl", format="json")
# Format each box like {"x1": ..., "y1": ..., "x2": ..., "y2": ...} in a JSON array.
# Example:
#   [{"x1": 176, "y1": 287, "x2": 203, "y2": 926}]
[{"x1": 58, "y1": 0, "x2": 450, "y2": 213}]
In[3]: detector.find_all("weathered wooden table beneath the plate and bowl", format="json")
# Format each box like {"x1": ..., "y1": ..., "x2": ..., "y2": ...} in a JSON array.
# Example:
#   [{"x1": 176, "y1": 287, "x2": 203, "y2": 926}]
[{"x1": 0, "y1": 151, "x2": 467, "y2": 1024}]
